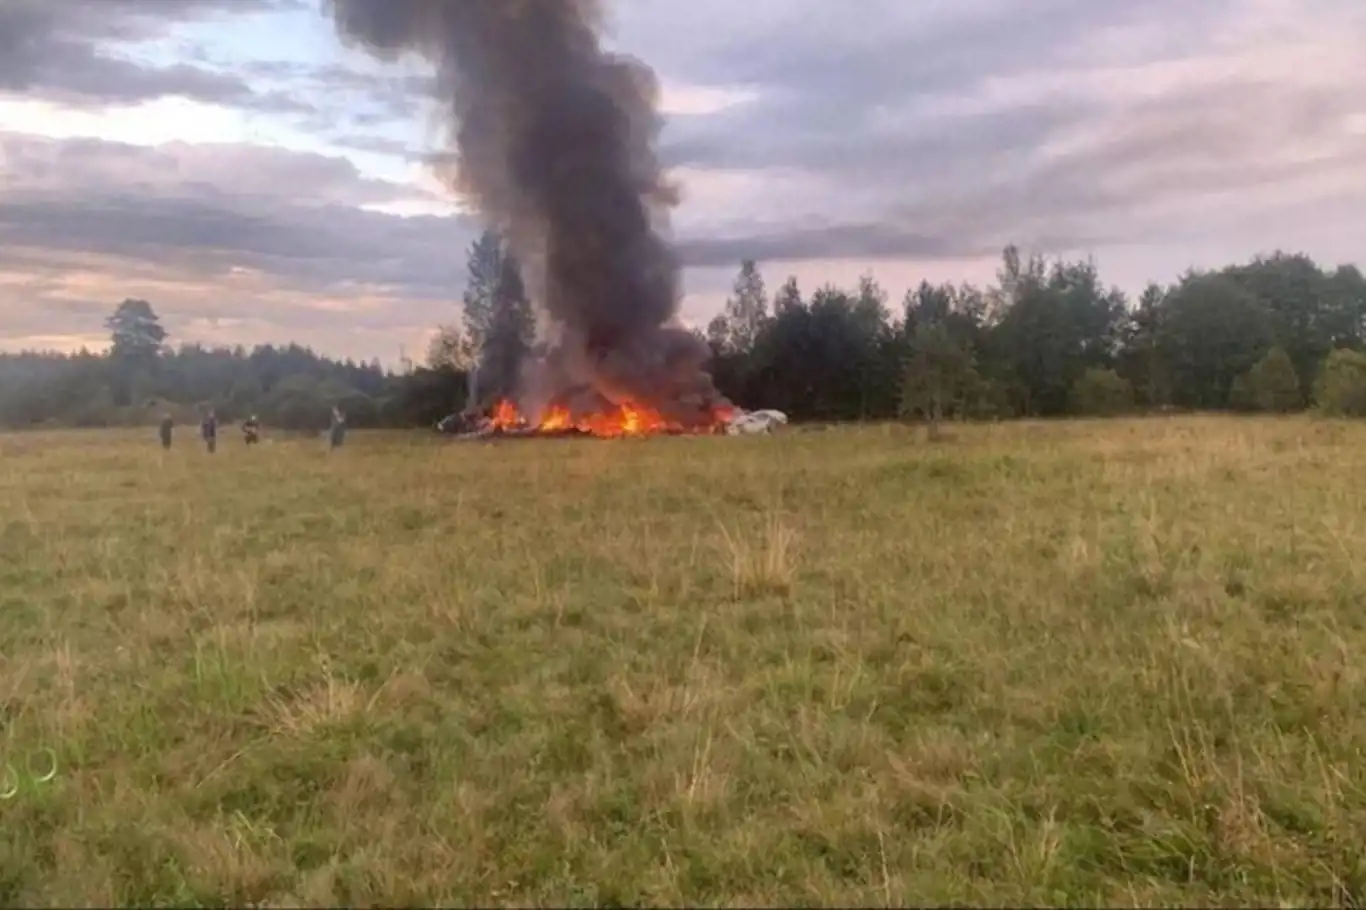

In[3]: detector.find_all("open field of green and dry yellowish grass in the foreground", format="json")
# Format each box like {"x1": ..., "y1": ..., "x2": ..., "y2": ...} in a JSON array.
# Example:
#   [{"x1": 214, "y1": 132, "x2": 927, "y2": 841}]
[{"x1": 0, "y1": 418, "x2": 1366, "y2": 906}]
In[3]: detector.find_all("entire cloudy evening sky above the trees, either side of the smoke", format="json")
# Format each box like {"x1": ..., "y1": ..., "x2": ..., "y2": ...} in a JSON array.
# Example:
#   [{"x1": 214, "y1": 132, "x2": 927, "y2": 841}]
[{"x1": 0, "y1": 0, "x2": 1366, "y2": 362}]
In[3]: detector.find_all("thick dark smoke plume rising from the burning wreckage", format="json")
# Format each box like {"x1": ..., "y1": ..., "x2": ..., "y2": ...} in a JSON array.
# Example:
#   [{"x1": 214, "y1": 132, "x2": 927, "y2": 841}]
[{"x1": 331, "y1": 0, "x2": 723, "y2": 422}]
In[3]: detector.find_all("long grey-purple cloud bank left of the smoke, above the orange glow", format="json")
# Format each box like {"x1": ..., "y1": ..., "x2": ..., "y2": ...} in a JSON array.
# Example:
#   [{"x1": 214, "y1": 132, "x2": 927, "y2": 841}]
[{"x1": 0, "y1": 134, "x2": 471, "y2": 299}]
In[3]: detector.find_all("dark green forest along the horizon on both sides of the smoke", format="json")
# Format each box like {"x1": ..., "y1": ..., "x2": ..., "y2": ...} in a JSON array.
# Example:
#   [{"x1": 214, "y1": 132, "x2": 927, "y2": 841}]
[{"x1": 0, "y1": 235, "x2": 1366, "y2": 430}]
